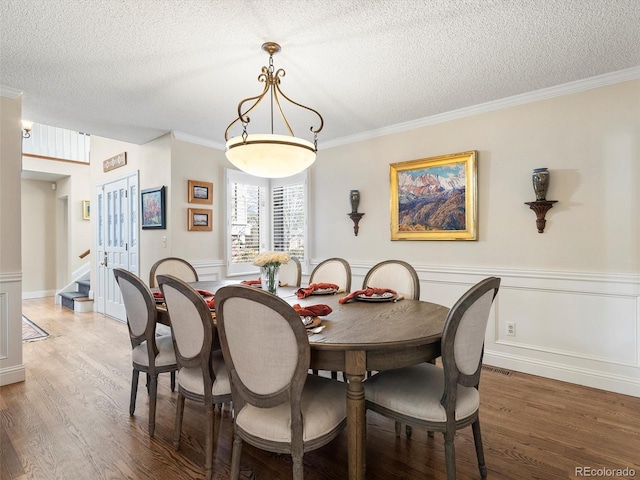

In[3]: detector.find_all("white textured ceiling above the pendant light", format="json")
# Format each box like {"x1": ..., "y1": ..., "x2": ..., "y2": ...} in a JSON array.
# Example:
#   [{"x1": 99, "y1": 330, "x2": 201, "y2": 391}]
[{"x1": 0, "y1": 0, "x2": 640, "y2": 146}]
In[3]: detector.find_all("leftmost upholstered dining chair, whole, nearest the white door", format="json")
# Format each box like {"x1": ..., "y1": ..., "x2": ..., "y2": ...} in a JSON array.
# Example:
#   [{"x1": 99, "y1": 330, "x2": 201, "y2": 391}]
[{"x1": 113, "y1": 268, "x2": 178, "y2": 437}]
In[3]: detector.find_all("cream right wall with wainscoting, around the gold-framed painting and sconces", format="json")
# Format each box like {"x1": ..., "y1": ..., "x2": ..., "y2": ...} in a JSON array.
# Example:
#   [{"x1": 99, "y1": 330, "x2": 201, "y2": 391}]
[{"x1": 312, "y1": 80, "x2": 640, "y2": 396}]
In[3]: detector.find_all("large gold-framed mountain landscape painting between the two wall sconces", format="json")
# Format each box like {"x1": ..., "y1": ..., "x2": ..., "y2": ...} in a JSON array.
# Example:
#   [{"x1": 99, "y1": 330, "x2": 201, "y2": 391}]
[{"x1": 389, "y1": 150, "x2": 478, "y2": 240}]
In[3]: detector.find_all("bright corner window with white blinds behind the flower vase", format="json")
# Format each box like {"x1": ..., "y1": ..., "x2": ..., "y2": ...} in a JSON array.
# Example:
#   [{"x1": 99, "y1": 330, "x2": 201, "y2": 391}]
[{"x1": 227, "y1": 170, "x2": 308, "y2": 275}]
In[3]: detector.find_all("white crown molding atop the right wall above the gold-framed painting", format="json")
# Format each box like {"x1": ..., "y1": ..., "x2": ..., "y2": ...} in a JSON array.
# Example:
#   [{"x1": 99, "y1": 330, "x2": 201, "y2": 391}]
[{"x1": 322, "y1": 67, "x2": 640, "y2": 148}]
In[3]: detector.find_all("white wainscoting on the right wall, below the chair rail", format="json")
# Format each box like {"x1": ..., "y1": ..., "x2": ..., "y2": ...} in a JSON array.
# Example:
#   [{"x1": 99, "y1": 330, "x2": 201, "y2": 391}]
[{"x1": 338, "y1": 259, "x2": 640, "y2": 397}]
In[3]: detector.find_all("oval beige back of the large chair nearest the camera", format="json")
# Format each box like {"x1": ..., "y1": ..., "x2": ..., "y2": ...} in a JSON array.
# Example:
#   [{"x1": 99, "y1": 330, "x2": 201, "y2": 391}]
[{"x1": 216, "y1": 285, "x2": 310, "y2": 412}]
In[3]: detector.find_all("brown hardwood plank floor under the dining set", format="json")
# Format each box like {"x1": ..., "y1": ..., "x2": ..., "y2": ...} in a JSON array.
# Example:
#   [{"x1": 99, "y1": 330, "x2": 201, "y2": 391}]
[{"x1": 5, "y1": 298, "x2": 640, "y2": 480}]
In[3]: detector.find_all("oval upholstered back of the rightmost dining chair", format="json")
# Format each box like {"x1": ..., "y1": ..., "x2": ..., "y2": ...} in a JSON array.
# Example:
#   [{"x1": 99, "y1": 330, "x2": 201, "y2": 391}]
[{"x1": 442, "y1": 277, "x2": 500, "y2": 390}]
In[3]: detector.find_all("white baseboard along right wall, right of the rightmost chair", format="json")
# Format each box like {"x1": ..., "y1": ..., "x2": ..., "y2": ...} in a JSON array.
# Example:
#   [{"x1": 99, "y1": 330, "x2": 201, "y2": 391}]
[{"x1": 483, "y1": 350, "x2": 640, "y2": 397}]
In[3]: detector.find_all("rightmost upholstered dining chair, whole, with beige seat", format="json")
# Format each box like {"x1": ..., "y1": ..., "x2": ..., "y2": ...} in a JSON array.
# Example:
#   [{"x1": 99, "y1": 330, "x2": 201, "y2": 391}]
[{"x1": 364, "y1": 277, "x2": 500, "y2": 480}]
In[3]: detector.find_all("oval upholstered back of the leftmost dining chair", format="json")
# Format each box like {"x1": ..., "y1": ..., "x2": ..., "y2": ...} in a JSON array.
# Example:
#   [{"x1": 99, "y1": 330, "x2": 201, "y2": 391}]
[{"x1": 113, "y1": 268, "x2": 158, "y2": 358}]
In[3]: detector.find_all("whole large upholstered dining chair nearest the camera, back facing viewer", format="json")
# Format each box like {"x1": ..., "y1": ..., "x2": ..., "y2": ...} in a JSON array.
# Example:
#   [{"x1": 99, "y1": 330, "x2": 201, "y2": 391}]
[{"x1": 216, "y1": 285, "x2": 347, "y2": 480}]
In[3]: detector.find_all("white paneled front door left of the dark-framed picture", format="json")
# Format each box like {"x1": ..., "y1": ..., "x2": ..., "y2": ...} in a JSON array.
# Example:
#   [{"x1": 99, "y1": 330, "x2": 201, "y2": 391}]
[{"x1": 95, "y1": 172, "x2": 140, "y2": 321}]
